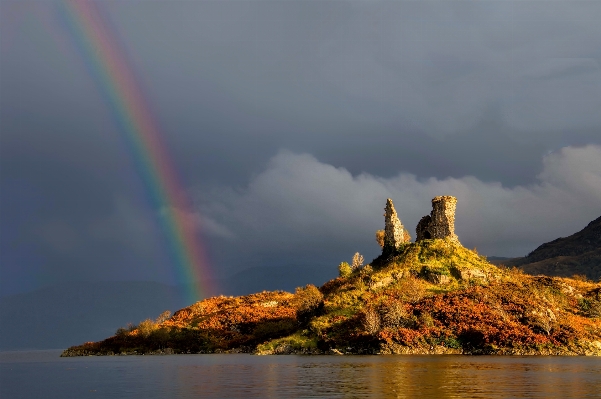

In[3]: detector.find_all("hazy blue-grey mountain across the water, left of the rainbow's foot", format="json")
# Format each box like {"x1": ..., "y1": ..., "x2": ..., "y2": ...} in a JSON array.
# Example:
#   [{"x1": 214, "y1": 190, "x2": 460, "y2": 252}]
[{"x1": 0, "y1": 282, "x2": 189, "y2": 350}]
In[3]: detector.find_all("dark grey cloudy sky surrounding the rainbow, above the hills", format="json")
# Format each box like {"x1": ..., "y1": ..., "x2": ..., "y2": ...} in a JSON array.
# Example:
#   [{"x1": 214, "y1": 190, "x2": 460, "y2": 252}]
[{"x1": 0, "y1": 0, "x2": 601, "y2": 295}]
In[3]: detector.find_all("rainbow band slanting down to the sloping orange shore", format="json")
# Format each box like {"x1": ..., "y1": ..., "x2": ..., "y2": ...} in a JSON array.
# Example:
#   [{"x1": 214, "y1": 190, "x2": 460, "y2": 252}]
[{"x1": 60, "y1": 0, "x2": 216, "y2": 303}]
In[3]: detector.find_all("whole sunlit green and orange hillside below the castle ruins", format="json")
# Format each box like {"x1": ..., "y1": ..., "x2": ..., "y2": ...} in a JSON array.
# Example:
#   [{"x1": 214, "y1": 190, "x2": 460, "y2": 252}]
[{"x1": 63, "y1": 240, "x2": 601, "y2": 356}]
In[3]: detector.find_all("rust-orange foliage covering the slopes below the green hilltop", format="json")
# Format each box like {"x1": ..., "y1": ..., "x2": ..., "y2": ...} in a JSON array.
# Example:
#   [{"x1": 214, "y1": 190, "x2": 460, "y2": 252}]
[{"x1": 62, "y1": 250, "x2": 601, "y2": 354}]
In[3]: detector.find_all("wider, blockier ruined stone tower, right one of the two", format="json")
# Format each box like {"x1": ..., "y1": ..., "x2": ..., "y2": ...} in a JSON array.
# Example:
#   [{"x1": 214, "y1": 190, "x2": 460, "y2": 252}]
[{"x1": 415, "y1": 195, "x2": 459, "y2": 242}]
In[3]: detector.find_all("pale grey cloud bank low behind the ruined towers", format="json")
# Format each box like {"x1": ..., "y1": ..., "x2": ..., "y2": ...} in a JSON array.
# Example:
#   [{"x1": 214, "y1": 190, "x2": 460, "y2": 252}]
[{"x1": 201, "y1": 146, "x2": 601, "y2": 267}]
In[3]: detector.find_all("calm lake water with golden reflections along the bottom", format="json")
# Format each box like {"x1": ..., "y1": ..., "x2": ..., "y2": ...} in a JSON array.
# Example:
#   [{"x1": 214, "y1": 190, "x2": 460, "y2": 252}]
[{"x1": 0, "y1": 351, "x2": 601, "y2": 399}]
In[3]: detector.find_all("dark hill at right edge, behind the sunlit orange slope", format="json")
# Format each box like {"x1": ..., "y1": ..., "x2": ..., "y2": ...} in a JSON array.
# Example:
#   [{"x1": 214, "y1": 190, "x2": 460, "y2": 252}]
[{"x1": 504, "y1": 217, "x2": 601, "y2": 281}]
